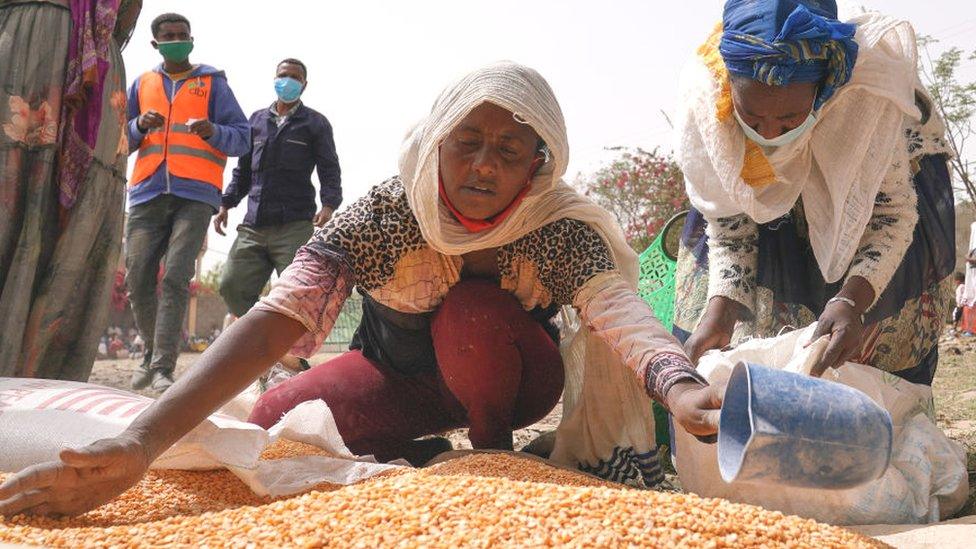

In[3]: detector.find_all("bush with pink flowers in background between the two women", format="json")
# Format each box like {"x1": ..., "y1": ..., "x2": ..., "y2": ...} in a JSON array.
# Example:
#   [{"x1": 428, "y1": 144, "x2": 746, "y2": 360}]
[{"x1": 576, "y1": 147, "x2": 689, "y2": 252}]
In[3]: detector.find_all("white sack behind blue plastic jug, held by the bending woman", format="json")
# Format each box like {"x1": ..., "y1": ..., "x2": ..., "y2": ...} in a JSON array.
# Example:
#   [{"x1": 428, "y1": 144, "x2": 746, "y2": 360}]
[{"x1": 672, "y1": 325, "x2": 968, "y2": 524}]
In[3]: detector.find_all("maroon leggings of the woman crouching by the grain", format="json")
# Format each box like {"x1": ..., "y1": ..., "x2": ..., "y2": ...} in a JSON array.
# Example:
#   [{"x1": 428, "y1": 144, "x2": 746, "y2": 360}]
[{"x1": 249, "y1": 280, "x2": 563, "y2": 461}]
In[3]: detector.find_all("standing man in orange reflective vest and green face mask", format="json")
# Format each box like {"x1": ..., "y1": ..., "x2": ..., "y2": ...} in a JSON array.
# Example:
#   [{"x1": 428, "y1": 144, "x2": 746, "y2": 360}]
[{"x1": 125, "y1": 13, "x2": 250, "y2": 391}]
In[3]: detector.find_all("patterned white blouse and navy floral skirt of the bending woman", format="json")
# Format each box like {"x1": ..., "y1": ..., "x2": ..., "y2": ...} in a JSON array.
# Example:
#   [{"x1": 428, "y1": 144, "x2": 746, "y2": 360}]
[{"x1": 673, "y1": 95, "x2": 955, "y2": 384}]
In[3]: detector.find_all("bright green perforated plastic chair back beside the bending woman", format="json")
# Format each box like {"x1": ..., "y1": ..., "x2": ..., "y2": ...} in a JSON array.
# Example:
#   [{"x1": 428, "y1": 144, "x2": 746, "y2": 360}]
[{"x1": 637, "y1": 212, "x2": 688, "y2": 332}]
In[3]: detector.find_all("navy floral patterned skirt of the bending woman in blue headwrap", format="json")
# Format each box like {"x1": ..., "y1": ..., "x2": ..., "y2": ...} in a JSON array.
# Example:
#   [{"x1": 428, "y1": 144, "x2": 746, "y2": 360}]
[{"x1": 673, "y1": 155, "x2": 955, "y2": 385}]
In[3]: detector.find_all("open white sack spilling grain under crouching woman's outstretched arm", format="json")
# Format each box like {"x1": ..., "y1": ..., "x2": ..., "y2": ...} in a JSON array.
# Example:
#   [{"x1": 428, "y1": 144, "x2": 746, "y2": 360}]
[{"x1": 0, "y1": 378, "x2": 396, "y2": 496}]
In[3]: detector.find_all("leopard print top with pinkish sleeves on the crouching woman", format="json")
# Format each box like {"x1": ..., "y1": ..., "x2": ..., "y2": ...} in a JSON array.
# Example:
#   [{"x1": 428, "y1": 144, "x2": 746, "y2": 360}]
[{"x1": 256, "y1": 178, "x2": 701, "y2": 400}]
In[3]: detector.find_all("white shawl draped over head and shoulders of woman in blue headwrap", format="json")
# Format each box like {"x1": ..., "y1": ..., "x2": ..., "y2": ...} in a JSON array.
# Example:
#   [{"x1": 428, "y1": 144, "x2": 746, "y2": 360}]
[{"x1": 675, "y1": 13, "x2": 921, "y2": 282}]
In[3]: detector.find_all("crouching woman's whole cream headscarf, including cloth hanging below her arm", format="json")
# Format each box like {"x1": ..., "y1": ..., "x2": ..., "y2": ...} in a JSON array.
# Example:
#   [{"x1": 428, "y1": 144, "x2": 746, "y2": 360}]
[{"x1": 400, "y1": 61, "x2": 655, "y2": 482}]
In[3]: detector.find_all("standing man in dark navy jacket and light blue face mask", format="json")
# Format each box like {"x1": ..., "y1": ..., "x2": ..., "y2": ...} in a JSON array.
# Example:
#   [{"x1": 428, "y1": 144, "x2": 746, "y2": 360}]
[{"x1": 214, "y1": 59, "x2": 342, "y2": 330}]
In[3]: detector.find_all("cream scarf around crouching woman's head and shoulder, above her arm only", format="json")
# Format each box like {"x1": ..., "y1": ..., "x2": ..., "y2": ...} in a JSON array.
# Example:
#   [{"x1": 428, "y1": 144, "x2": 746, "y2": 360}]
[{"x1": 400, "y1": 61, "x2": 637, "y2": 282}]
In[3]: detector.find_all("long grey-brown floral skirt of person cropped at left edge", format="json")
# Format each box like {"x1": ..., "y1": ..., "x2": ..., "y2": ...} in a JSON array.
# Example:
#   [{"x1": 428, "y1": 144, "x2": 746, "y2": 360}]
[{"x1": 0, "y1": 2, "x2": 128, "y2": 380}]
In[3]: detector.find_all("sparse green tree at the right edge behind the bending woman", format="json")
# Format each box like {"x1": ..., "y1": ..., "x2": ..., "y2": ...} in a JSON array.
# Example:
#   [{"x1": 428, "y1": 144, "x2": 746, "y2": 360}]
[{"x1": 918, "y1": 36, "x2": 976, "y2": 205}]
